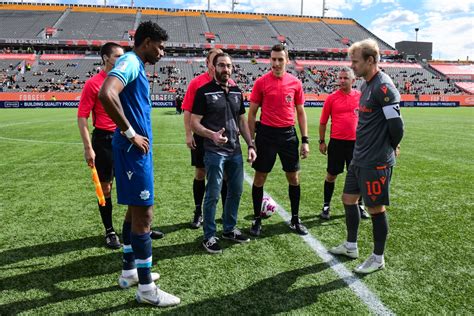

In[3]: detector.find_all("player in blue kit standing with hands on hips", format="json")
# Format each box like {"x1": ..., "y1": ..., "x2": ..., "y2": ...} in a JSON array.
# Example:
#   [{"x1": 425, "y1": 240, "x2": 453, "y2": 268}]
[{"x1": 99, "y1": 21, "x2": 180, "y2": 306}]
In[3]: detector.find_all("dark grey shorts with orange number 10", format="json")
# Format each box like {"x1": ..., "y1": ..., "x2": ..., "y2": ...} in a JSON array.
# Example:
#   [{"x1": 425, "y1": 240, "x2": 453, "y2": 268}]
[{"x1": 344, "y1": 164, "x2": 392, "y2": 207}]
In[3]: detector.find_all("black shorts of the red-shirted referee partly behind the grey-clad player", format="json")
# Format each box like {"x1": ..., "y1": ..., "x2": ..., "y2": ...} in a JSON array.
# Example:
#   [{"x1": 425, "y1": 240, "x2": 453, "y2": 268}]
[{"x1": 327, "y1": 138, "x2": 355, "y2": 176}]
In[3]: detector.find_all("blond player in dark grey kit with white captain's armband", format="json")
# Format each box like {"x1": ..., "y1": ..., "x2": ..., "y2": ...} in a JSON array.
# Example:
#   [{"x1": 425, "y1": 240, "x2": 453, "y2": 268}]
[{"x1": 329, "y1": 39, "x2": 403, "y2": 274}]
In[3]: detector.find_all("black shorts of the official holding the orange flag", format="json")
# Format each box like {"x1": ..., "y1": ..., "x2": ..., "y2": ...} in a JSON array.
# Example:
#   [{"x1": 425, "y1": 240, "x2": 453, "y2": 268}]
[{"x1": 92, "y1": 128, "x2": 114, "y2": 182}]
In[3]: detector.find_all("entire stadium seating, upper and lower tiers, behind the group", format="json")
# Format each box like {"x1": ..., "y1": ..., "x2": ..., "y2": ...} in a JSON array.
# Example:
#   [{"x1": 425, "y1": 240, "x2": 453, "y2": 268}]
[{"x1": 0, "y1": 3, "x2": 474, "y2": 96}]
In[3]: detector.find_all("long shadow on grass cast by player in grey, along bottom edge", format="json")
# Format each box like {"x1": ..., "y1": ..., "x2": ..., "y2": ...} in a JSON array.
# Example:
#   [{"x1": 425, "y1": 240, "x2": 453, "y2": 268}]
[{"x1": 81, "y1": 263, "x2": 351, "y2": 316}]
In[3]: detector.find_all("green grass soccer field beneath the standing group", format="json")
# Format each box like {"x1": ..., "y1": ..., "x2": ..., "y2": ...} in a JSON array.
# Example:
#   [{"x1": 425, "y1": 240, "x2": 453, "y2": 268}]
[{"x1": 0, "y1": 108, "x2": 474, "y2": 315}]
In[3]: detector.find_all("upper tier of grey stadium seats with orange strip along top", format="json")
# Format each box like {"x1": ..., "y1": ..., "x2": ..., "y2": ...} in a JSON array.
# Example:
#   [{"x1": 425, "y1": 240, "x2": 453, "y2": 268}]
[{"x1": 0, "y1": 4, "x2": 395, "y2": 52}]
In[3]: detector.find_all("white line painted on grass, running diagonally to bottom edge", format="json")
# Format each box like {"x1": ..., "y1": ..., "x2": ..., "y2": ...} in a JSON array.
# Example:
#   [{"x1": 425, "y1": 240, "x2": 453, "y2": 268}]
[{"x1": 244, "y1": 172, "x2": 394, "y2": 315}]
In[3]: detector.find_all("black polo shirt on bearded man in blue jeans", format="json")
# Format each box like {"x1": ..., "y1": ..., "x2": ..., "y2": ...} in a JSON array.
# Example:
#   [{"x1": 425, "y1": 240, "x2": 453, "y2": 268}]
[{"x1": 192, "y1": 80, "x2": 245, "y2": 156}]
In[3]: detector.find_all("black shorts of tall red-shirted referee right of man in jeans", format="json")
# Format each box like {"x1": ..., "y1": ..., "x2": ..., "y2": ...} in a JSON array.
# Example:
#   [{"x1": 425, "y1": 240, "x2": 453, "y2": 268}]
[{"x1": 252, "y1": 124, "x2": 300, "y2": 173}]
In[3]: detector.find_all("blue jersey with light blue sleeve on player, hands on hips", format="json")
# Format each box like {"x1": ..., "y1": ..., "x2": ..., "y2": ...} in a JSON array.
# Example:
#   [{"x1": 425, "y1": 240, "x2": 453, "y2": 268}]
[{"x1": 108, "y1": 52, "x2": 153, "y2": 151}]
